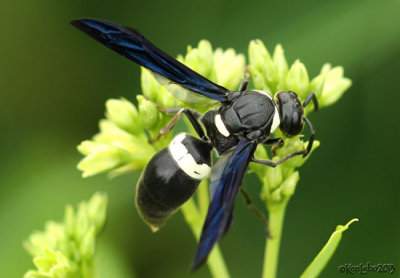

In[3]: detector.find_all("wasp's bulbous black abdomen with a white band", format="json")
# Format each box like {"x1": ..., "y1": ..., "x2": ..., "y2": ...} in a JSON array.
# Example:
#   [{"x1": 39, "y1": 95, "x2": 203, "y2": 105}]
[{"x1": 136, "y1": 133, "x2": 211, "y2": 231}]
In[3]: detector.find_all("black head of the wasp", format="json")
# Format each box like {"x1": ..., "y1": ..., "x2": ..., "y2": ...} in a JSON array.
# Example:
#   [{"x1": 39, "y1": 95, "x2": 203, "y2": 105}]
[{"x1": 275, "y1": 91, "x2": 304, "y2": 136}]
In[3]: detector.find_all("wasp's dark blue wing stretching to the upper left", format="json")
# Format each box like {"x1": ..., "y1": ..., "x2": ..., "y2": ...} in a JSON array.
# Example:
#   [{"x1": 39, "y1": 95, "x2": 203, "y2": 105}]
[{"x1": 71, "y1": 19, "x2": 230, "y2": 101}]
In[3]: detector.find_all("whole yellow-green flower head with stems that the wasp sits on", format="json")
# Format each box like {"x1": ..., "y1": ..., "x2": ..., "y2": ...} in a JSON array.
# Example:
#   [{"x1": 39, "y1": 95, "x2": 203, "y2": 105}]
[{"x1": 72, "y1": 37, "x2": 351, "y2": 277}]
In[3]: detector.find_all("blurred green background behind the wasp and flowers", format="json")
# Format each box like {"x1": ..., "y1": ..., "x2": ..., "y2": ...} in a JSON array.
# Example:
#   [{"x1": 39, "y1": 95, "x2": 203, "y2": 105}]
[{"x1": 0, "y1": 0, "x2": 400, "y2": 278}]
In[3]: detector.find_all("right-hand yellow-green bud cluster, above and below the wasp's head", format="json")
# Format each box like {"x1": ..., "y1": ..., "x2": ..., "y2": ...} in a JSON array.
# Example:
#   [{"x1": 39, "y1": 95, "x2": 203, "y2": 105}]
[{"x1": 249, "y1": 40, "x2": 351, "y2": 209}]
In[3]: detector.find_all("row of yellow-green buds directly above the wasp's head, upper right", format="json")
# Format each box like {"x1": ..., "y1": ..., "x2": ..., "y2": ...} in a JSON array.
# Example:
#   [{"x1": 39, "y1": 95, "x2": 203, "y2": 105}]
[{"x1": 249, "y1": 40, "x2": 351, "y2": 108}]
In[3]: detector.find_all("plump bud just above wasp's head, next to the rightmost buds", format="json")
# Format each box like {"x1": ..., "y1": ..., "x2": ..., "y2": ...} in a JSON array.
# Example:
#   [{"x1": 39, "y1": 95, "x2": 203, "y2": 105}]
[{"x1": 285, "y1": 60, "x2": 310, "y2": 99}]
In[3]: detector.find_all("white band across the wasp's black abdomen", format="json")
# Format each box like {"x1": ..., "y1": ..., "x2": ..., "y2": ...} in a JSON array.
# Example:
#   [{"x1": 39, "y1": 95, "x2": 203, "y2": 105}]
[{"x1": 168, "y1": 133, "x2": 211, "y2": 180}]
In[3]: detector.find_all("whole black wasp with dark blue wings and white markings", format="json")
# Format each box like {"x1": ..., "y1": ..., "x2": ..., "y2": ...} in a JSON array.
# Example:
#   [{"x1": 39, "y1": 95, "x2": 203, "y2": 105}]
[{"x1": 71, "y1": 19, "x2": 318, "y2": 270}]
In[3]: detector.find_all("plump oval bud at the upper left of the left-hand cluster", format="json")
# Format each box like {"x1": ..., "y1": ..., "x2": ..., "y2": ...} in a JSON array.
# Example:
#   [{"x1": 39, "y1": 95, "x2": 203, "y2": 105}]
[{"x1": 106, "y1": 98, "x2": 142, "y2": 134}]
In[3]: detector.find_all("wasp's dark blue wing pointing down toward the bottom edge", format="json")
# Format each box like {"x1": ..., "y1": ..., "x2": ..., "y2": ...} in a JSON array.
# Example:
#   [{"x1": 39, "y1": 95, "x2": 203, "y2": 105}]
[{"x1": 192, "y1": 139, "x2": 257, "y2": 270}]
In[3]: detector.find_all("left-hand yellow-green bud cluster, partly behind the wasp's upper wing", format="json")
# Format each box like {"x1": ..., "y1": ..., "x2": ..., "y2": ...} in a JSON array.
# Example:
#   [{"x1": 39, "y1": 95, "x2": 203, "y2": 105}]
[{"x1": 78, "y1": 40, "x2": 245, "y2": 177}]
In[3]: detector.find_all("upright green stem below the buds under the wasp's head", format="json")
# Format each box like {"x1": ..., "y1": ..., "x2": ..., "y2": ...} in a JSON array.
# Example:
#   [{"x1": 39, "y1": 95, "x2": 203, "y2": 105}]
[{"x1": 262, "y1": 202, "x2": 287, "y2": 278}]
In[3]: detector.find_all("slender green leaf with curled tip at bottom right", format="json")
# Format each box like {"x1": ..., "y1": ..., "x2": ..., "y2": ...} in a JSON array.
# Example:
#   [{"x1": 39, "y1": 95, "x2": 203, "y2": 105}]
[{"x1": 301, "y1": 218, "x2": 358, "y2": 278}]
